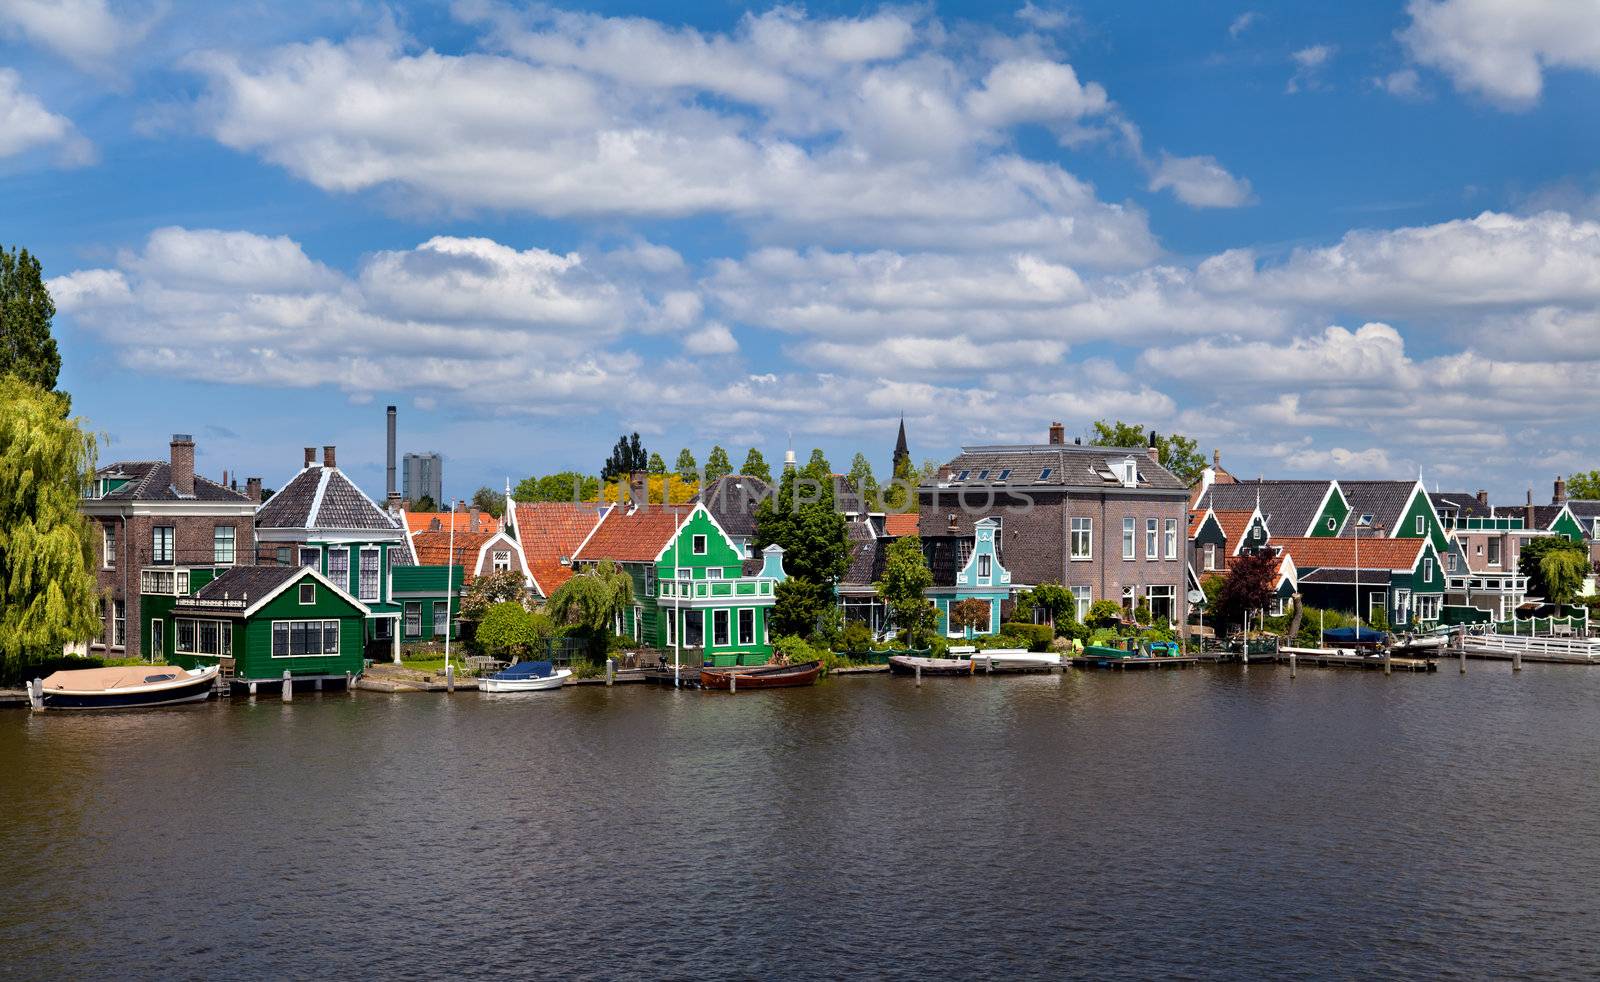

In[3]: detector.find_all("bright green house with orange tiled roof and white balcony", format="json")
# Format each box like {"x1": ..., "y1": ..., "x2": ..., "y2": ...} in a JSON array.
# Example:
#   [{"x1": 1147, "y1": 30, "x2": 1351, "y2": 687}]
[{"x1": 573, "y1": 504, "x2": 786, "y2": 665}]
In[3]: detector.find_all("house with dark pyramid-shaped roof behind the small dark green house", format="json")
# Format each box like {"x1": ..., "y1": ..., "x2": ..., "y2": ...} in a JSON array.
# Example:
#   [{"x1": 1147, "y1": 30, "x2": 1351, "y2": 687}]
[{"x1": 256, "y1": 446, "x2": 411, "y2": 657}]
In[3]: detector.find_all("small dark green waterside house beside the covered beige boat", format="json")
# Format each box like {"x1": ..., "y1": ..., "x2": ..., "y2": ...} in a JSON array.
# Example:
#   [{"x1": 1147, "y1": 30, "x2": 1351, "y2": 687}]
[{"x1": 162, "y1": 566, "x2": 371, "y2": 685}]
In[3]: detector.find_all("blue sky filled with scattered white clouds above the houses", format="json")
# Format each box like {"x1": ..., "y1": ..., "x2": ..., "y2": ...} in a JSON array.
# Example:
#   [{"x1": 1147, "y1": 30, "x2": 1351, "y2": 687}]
[{"x1": 0, "y1": 0, "x2": 1600, "y2": 499}]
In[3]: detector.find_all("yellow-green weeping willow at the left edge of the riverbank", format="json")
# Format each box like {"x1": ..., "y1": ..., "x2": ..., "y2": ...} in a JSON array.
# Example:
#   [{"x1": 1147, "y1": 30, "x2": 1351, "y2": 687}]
[{"x1": 0, "y1": 376, "x2": 101, "y2": 675}]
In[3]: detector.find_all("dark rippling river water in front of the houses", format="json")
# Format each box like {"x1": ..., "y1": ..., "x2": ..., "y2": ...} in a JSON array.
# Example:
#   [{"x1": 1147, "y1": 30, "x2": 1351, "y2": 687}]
[{"x1": 0, "y1": 662, "x2": 1600, "y2": 979}]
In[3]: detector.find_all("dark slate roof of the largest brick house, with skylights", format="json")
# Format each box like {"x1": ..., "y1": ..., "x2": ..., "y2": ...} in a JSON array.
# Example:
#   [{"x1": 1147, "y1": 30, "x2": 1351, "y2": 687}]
[{"x1": 939, "y1": 443, "x2": 1189, "y2": 493}]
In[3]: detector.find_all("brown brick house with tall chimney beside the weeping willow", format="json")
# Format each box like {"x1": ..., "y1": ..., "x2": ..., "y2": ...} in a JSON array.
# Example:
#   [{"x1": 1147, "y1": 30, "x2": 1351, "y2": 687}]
[{"x1": 78, "y1": 433, "x2": 261, "y2": 657}]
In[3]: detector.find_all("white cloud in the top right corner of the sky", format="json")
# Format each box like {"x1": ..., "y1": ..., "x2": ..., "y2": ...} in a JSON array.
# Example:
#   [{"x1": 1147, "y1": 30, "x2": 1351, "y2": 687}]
[{"x1": 1400, "y1": 0, "x2": 1600, "y2": 109}]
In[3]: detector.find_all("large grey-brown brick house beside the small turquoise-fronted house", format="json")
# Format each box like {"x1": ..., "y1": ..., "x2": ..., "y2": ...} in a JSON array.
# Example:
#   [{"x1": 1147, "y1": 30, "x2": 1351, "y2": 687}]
[{"x1": 917, "y1": 422, "x2": 1189, "y2": 624}]
